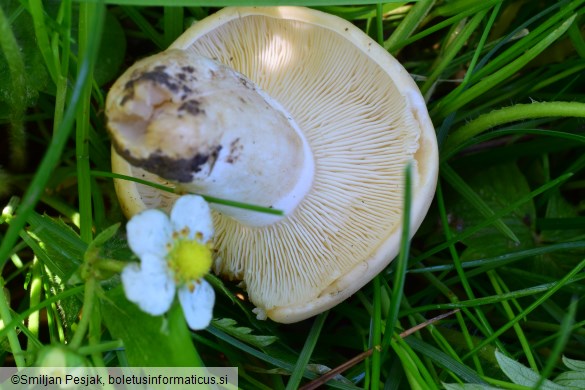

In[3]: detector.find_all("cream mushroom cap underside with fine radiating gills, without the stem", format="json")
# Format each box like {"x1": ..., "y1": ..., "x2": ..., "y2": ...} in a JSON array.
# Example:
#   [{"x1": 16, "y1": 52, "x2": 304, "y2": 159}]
[{"x1": 113, "y1": 7, "x2": 438, "y2": 323}]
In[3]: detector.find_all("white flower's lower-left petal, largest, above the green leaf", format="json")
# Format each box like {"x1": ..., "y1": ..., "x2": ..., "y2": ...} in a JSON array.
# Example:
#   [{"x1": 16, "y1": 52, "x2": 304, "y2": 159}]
[{"x1": 121, "y1": 255, "x2": 176, "y2": 316}]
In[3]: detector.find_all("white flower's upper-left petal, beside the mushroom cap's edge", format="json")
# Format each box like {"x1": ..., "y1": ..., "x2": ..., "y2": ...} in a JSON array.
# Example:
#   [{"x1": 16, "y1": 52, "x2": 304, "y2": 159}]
[{"x1": 126, "y1": 209, "x2": 173, "y2": 258}]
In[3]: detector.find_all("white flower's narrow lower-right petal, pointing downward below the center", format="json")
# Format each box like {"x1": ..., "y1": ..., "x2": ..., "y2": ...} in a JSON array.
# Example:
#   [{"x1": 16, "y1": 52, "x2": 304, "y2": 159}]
[{"x1": 179, "y1": 280, "x2": 215, "y2": 330}]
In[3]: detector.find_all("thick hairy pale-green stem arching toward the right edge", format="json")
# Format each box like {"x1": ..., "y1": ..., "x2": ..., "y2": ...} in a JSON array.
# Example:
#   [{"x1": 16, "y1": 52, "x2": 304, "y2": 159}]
[{"x1": 443, "y1": 102, "x2": 585, "y2": 159}]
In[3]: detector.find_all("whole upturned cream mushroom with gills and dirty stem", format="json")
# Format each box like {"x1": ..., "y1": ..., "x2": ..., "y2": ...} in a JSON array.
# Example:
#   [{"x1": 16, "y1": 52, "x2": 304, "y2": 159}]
[{"x1": 106, "y1": 7, "x2": 438, "y2": 323}]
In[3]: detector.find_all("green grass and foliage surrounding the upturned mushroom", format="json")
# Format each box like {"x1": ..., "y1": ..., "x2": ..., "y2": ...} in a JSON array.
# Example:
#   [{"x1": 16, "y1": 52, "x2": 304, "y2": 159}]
[{"x1": 0, "y1": 0, "x2": 585, "y2": 389}]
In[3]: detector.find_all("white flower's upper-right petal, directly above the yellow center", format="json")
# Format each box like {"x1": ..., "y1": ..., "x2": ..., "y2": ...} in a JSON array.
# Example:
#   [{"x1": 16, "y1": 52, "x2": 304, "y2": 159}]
[{"x1": 171, "y1": 195, "x2": 213, "y2": 242}]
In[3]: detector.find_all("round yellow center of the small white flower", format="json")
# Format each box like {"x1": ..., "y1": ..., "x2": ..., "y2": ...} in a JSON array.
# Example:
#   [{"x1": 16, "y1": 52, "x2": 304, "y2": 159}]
[{"x1": 167, "y1": 238, "x2": 213, "y2": 284}]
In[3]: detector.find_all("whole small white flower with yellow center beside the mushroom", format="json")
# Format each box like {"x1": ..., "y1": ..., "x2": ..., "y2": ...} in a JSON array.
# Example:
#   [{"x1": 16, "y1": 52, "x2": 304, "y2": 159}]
[{"x1": 122, "y1": 195, "x2": 215, "y2": 330}]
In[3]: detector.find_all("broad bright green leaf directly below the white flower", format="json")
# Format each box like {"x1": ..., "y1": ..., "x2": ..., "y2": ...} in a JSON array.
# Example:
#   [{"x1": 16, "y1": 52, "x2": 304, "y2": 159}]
[{"x1": 102, "y1": 285, "x2": 201, "y2": 367}]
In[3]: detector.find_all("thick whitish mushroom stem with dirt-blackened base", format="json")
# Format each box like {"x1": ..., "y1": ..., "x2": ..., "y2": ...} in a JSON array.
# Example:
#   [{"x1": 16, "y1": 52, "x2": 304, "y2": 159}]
[{"x1": 106, "y1": 49, "x2": 315, "y2": 226}]
